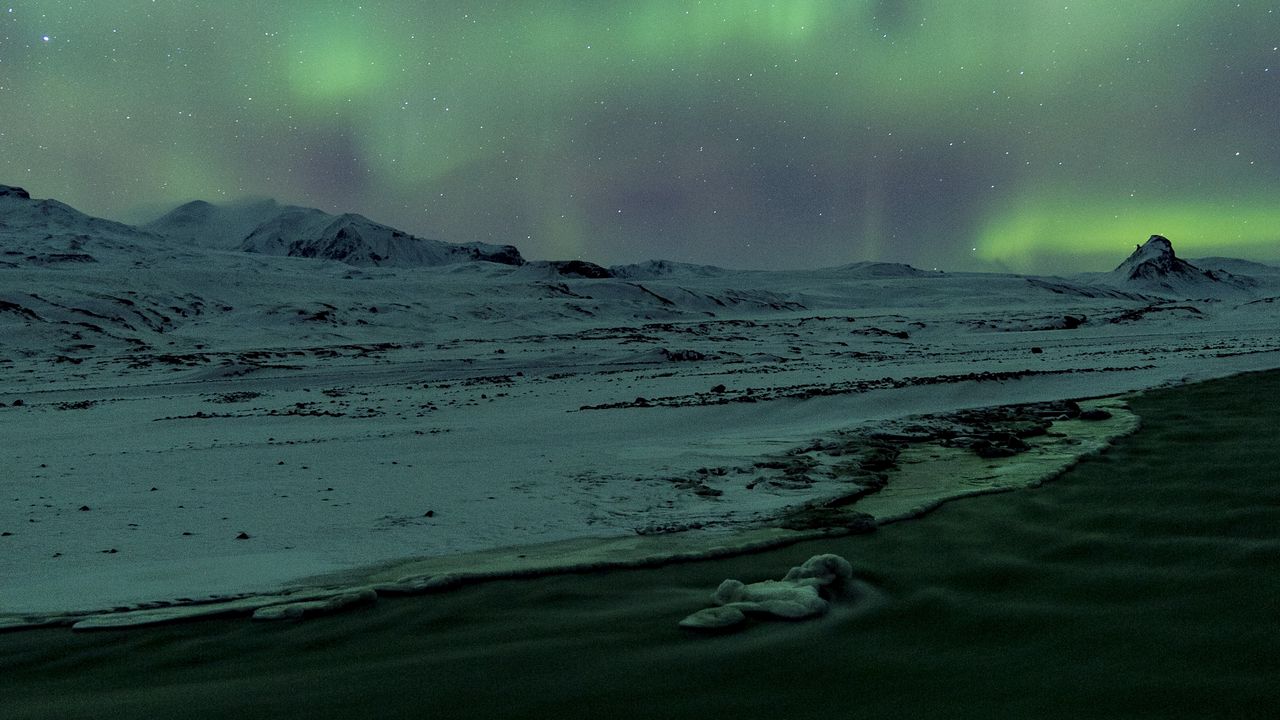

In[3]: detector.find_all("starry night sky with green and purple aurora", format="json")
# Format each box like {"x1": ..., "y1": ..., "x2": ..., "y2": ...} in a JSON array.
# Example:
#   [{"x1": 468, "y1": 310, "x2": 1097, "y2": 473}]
[{"x1": 0, "y1": 0, "x2": 1280, "y2": 273}]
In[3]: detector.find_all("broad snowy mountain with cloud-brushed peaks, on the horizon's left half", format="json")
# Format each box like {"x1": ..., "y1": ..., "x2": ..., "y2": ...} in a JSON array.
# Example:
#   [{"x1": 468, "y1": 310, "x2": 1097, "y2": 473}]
[{"x1": 143, "y1": 200, "x2": 524, "y2": 268}]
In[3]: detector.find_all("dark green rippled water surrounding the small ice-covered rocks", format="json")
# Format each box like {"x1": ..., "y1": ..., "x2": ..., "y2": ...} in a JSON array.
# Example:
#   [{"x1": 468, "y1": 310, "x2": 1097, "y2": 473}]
[{"x1": 0, "y1": 373, "x2": 1280, "y2": 719}]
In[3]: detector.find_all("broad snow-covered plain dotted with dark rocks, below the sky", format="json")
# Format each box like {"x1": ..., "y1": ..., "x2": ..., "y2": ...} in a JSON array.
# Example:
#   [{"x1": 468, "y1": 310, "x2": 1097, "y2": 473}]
[{"x1": 0, "y1": 187, "x2": 1280, "y2": 624}]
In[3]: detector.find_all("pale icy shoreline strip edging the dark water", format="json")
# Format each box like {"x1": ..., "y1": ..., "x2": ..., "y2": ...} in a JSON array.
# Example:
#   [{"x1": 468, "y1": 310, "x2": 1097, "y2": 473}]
[{"x1": 0, "y1": 389, "x2": 1139, "y2": 630}]
